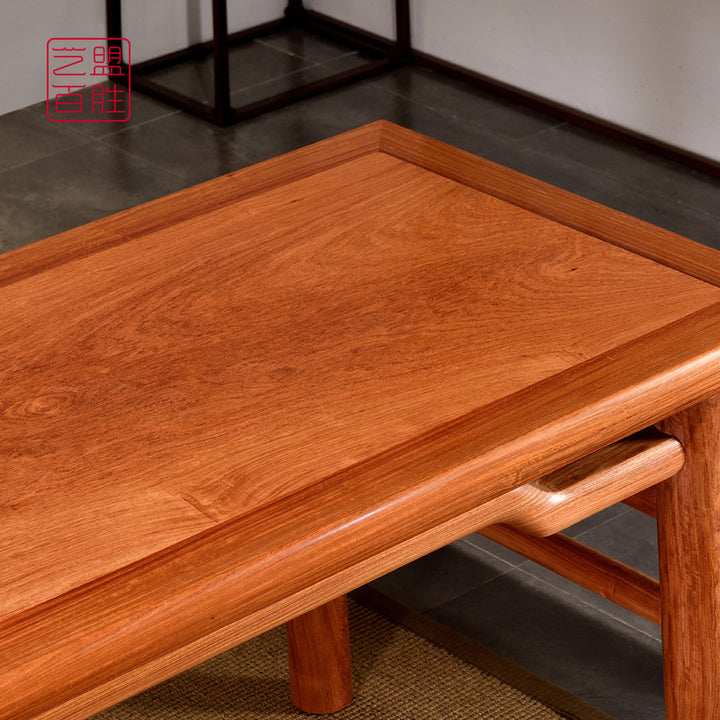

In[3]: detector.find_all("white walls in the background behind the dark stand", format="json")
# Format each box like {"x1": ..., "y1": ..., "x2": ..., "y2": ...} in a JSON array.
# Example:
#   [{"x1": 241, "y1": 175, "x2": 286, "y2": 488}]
[{"x1": 0, "y1": 0, "x2": 720, "y2": 160}]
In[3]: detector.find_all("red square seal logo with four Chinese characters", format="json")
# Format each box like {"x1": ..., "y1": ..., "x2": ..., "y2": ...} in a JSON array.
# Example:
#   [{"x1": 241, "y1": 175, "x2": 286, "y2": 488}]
[{"x1": 47, "y1": 38, "x2": 130, "y2": 122}]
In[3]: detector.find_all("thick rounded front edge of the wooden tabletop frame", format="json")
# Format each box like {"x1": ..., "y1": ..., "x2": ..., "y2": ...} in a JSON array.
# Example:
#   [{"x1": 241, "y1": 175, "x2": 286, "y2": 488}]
[{"x1": 0, "y1": 318, "x2": 717, "y2": 720}]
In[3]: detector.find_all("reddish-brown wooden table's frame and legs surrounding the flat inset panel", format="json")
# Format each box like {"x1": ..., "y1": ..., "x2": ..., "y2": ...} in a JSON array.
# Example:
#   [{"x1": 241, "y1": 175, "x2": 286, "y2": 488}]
[{"x1": 0, "y1": 122, "x2": 720, "y2": 720}]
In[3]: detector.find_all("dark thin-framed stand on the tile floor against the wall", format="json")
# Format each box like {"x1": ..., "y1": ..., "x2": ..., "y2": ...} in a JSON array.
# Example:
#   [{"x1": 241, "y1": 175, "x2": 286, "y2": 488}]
[{"x1": 105, "y1": 0, "x2": 412, "y2": 125}]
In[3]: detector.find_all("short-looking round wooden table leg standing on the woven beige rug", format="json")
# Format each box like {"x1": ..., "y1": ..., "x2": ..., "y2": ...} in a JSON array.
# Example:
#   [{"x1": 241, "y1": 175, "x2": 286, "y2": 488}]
[{"x1": 287, "y1": 596, "x2": 352, "y2": 713}]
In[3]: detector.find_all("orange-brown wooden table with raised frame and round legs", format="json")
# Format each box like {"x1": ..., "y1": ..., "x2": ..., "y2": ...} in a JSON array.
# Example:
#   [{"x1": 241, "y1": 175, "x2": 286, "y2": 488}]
[{"x1": 0, "y1": 122, "x2": 720, "y2": 720}]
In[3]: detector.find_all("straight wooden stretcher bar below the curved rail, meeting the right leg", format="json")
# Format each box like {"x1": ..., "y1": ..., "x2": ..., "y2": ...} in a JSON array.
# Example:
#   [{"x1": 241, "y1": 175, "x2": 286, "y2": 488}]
[{"x1": 479, "y1": 525, "x2": 660, "y2": 624}]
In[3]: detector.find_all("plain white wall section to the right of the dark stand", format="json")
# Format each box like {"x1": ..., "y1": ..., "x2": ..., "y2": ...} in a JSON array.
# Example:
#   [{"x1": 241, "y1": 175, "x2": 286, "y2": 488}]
[{"x1": 413, "y1": 0, "x2": 720, "y2": 160}]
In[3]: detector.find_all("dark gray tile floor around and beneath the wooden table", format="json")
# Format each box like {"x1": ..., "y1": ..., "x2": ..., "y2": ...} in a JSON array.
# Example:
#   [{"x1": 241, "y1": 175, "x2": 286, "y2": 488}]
[{"x1": 0, "y1": 28, "x2": 720, "y2": 720}]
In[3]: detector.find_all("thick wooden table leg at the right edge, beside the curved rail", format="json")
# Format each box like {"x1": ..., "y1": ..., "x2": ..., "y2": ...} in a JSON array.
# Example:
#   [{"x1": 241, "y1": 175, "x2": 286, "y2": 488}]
[{"x1": 657, "y1": 396, "x2": 720, "y2": 720}]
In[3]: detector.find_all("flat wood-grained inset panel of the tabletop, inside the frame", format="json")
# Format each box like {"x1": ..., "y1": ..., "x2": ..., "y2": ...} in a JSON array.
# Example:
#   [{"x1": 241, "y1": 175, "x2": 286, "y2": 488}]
[{"x1": 0, "y1": 121, "x2": 720, "y2": 620}]
